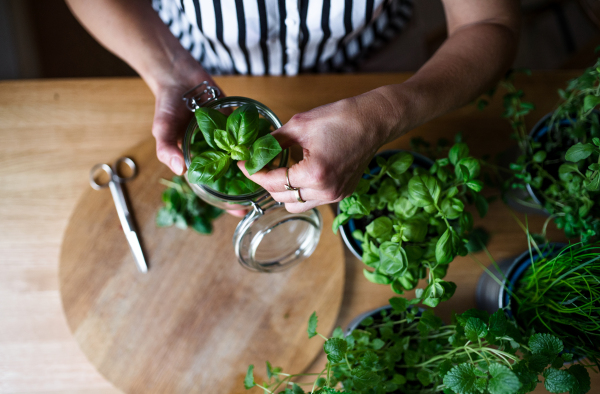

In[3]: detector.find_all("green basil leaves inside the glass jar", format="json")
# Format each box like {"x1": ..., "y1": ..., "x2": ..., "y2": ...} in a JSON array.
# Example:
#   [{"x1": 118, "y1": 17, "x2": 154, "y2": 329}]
[{"x1": 188, "y1": 104, "x2": 282, "y2": 195}]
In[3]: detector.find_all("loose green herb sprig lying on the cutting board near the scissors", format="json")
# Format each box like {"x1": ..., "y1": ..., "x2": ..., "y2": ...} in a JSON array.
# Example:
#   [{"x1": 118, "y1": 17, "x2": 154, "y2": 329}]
[{"x1": 156, "y1": 176, "x2": 223, "y2": 234}]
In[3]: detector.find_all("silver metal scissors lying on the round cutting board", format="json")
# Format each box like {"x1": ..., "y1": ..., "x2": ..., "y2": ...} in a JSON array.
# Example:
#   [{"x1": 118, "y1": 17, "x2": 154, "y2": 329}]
[{"x1": 90, "y1": 157, "x2": 148, "y2": 273}]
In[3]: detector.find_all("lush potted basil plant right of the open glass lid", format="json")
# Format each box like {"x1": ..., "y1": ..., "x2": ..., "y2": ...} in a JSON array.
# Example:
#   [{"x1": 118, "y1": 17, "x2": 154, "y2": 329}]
[{"x1": 333, "y1": 142, "x2": 488, "y2": 307}]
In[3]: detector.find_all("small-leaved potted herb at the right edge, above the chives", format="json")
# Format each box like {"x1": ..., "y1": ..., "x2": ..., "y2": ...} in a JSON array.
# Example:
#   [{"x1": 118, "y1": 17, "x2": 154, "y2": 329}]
[{"x1": 503, "y1": 60, "x2": 600, "y2": 243}]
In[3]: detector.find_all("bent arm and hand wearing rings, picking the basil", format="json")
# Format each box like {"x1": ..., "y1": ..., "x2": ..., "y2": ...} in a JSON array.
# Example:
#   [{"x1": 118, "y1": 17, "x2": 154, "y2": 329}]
[{"x1": 241, "y1": 0, "x2": 519, "y2": 212}]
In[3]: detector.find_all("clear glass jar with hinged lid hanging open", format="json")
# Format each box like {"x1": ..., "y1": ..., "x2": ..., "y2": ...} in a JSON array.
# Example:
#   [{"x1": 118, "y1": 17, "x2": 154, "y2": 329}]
[{"x1": 182, "y1": 82, "x2": 322, "y2": 272}]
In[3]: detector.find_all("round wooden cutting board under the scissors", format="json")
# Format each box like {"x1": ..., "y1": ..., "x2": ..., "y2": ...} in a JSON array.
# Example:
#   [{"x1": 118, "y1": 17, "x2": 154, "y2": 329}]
[{"x1": 60, "y1": 140, "x2": 344, "y2": 394}]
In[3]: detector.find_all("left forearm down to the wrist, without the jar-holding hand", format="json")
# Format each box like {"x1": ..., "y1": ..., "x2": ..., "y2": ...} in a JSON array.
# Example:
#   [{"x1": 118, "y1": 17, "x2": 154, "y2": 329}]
[{"x1": 67, "y1": 0, "x2": 202, "y2": 95}]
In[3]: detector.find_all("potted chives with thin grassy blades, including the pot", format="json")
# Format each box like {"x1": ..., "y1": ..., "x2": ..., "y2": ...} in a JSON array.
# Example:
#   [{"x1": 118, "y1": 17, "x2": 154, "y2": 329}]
[{"x1": 477, "y1": 243, "x2": 600, "y2": 366}]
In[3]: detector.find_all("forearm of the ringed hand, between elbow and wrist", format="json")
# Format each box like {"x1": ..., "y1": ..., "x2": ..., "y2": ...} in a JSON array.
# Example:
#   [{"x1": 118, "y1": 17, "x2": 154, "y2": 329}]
[{"x1": 379, "y1": 23, "x2": 517, "y2": 142}]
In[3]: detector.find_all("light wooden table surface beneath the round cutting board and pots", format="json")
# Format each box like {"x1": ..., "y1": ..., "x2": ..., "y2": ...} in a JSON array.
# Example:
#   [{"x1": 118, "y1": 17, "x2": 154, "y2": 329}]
[{"x1": 0, "y1": 72, "x2": 600, "y2": 394}]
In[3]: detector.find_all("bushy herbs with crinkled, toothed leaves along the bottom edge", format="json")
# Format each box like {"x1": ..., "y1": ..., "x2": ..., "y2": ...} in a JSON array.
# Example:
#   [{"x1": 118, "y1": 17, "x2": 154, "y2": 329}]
[{"x1": 244, "y1": 297, "x2": 590, "y2": 394}]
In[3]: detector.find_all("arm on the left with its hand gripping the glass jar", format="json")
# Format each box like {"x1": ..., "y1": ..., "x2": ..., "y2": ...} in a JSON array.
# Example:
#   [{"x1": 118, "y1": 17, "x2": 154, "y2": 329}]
[{"x1": 66, "y1": 0, "x2": 216, "y2": 175}]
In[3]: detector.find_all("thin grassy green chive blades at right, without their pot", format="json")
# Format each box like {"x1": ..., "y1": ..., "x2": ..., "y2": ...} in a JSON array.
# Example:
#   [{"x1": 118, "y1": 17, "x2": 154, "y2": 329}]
[{"x1": 512, "y1": 243, "x2": 600, "y2": 366}]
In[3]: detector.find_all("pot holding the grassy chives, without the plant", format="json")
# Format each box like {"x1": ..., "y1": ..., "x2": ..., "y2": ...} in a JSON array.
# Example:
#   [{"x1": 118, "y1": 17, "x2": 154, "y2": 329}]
[{"x1": 475, "y1": 242, "x2": 567, "y2": 316}]
